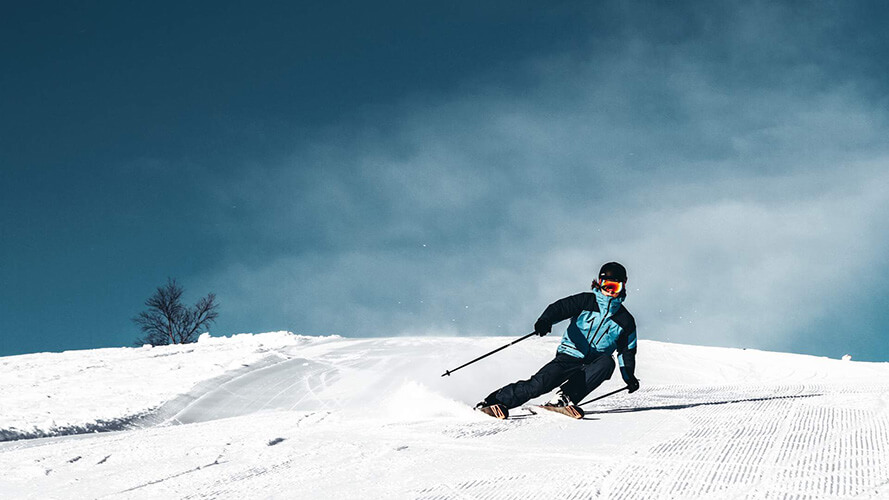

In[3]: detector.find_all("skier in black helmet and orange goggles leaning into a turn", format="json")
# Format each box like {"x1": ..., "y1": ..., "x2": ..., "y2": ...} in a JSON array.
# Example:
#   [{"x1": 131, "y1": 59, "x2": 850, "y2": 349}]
[{"x1": 476, "y1": 262, "x2": 639, "y2": 418}]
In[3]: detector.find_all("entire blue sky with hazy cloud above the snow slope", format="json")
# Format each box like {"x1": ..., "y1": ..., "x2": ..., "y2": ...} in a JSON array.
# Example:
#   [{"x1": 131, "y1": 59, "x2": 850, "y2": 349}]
[{"x1": 0, "y1": 2, "x2": 889, "y2": 360}]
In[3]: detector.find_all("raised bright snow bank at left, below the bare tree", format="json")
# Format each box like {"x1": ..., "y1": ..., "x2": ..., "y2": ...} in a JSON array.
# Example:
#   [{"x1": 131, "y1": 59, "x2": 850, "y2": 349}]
[{"x1": 0, "y1": 332, "x2": 310, "y2": 440}]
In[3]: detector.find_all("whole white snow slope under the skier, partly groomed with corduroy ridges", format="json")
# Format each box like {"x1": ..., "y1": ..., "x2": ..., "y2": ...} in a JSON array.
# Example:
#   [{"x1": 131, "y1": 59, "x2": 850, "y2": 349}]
[{"x1": 0, "y1": 332, "x2": 889, "y2": 499}]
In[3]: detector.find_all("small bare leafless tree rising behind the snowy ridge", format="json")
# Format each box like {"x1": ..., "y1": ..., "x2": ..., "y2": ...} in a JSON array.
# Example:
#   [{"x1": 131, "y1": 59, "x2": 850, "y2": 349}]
[{"x1": 133, "y1": 278, "x2": 219, "y2": 345}]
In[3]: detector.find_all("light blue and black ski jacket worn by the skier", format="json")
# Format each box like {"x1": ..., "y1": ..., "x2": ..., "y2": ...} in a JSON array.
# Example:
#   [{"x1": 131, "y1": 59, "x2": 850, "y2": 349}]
[{"x1": 538, "y1": 290, "x2": 636, "y2": 381}]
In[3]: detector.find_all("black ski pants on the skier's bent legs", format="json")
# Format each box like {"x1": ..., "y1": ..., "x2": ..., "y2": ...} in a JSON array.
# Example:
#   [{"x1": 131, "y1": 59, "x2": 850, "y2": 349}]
[{"x1": 485, "y1": 353, "x2": 614, "y2": 408}]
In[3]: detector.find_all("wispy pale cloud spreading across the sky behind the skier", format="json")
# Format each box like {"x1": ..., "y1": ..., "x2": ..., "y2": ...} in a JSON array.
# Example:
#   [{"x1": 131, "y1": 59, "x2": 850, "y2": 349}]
[{"x1": 208, "y1": 6, "x2": 889, "y2": 362}]
